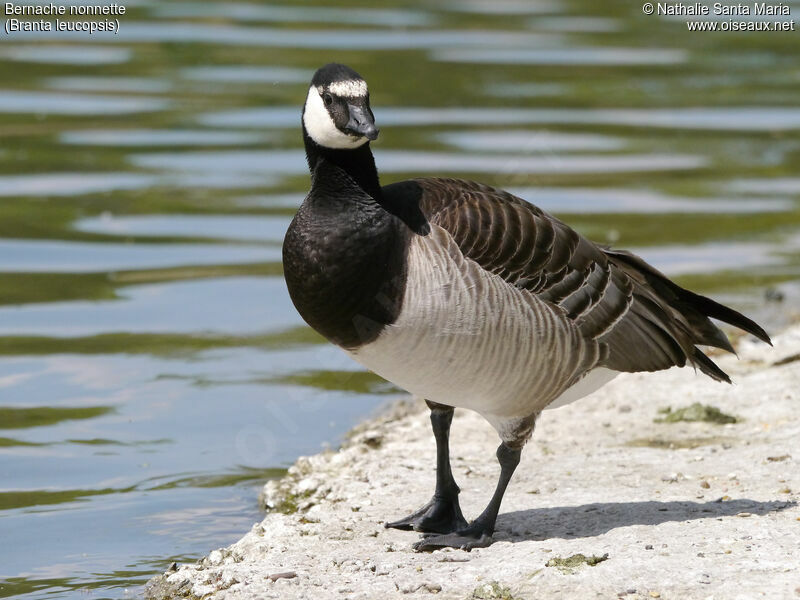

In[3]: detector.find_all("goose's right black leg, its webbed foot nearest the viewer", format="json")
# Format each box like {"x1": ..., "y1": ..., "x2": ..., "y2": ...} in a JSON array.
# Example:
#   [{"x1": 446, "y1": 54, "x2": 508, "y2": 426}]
[{"x1": 414, "y1": 442, "x2": 522, "y2": 551}]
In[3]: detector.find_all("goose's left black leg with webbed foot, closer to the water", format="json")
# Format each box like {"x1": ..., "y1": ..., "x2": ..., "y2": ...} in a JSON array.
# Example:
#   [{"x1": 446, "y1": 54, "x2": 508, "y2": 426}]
[{"x1": 386, "y1": 400, "x2": 467, "y2": 533}]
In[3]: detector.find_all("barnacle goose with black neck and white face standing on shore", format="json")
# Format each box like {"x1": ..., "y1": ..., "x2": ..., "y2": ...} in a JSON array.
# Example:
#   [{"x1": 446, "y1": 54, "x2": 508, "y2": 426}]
[{"x1": 283, "y1": 63, "x2": 771, "y2": 551}]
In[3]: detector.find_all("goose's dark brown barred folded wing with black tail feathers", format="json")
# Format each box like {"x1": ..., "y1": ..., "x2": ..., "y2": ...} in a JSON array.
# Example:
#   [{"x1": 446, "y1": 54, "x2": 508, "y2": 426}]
[{"x1": 396, "y1": 179, "x2": 769, "y2": 381}]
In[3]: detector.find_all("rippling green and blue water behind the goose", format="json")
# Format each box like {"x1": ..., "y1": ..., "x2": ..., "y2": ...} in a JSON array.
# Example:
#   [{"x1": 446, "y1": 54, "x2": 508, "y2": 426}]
[{"x1": 0, "y1": 0, "x2": 800, "y2": 598}]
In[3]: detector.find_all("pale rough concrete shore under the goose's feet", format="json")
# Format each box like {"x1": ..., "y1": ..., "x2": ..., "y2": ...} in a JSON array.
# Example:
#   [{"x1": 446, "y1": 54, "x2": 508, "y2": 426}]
[{"x1": 146, "y1": 326, "x2": 800, "y2": 600}]
